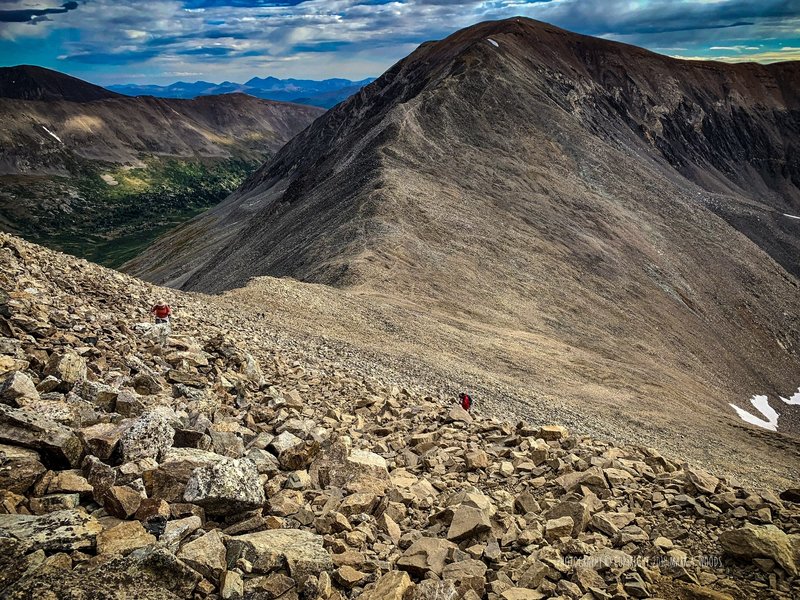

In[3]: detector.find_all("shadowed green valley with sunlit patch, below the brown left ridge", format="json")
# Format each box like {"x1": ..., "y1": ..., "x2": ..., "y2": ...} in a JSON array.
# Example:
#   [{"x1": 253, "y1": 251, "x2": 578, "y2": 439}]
[{"x1": 0, "y1": 157, "x2": 261, "y2": 267}]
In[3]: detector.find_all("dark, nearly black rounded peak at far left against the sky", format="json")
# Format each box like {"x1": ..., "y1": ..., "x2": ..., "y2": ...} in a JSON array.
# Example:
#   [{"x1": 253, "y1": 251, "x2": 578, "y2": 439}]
[{"x1": 0, "y1": 65, "x2": 121, "y2": 102}]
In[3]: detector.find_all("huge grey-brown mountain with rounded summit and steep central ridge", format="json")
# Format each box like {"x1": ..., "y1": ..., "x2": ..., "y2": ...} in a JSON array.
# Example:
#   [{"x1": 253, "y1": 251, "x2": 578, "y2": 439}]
[{"x1": 129, "y1": 19, "x2": 800, "y2": 435}]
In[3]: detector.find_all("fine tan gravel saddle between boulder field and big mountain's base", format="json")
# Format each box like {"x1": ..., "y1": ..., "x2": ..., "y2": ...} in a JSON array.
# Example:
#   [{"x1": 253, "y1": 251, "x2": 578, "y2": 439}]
[{"x1": 169, "y1": 279, "x2": 800, "y2": 489}]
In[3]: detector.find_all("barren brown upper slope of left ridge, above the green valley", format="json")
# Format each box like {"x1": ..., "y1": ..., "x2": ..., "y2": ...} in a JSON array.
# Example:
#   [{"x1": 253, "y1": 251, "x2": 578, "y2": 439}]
[{"x1": 0, "y1": 89, "x2": 324, "y2": 175}]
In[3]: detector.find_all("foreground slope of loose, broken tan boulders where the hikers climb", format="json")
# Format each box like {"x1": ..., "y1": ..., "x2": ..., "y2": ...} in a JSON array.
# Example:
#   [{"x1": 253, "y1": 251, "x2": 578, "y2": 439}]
[{"x1": 0, "y1": 234, "x2": 800, "y2": 600}]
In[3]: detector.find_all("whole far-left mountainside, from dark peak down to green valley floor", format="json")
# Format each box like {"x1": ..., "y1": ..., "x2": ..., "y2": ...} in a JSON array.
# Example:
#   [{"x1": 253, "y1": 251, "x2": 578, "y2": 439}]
[{"x1": 0, "y1": 68, "x2": 323, "y2": 265}]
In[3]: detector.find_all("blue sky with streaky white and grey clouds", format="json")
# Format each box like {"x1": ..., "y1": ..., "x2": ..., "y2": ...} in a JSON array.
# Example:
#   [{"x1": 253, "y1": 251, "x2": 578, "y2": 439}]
[{"x1": 0, "y1": 0, "x2": 800, "y2": 85}]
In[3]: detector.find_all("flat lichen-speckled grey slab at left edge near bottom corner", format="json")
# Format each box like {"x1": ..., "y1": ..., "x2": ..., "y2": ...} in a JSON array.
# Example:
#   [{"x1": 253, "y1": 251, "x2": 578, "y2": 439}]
[{"x1": 0, "y1": 510, "x2": 103, "y2": 552}]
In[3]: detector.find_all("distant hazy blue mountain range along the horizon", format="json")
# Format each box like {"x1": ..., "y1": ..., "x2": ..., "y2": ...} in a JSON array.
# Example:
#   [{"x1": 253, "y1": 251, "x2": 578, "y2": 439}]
[{"x1": 108, "y1": 77, "x2": 375, "y2": 108}]
